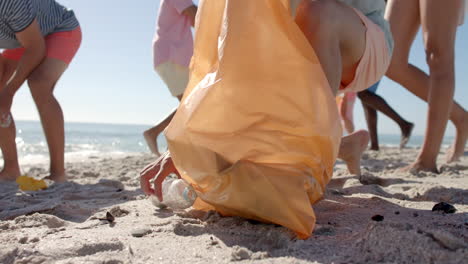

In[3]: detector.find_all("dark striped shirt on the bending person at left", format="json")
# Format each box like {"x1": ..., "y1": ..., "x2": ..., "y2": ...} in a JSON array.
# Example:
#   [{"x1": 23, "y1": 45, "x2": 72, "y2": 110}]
[{"x1": 0, "y1": 0, "x2": 79, "y2": 49}]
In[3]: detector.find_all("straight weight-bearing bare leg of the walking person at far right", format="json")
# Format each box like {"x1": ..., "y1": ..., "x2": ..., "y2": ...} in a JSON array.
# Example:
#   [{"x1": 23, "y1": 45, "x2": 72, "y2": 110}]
[{"x1": 415, "y1": 0, "x2": 462, "y2": 169}]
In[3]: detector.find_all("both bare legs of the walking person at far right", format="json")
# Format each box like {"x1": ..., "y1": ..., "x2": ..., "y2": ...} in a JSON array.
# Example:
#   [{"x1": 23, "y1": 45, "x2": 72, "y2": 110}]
[{"x1": 387, "y1": 0, "x2": 468, "y2": 171}]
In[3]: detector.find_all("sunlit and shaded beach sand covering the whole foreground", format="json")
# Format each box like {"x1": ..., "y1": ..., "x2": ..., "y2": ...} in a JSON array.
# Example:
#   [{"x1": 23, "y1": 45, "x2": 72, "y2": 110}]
[{"x1": 0, "y1": 148, "x2": 468, "y2": 264}]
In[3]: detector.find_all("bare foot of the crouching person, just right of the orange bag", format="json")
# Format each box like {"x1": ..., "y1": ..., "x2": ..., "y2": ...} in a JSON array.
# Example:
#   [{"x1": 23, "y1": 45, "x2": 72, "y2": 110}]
[{"x1": 338, "y1": 130, "x2": 369, "y2": 176}]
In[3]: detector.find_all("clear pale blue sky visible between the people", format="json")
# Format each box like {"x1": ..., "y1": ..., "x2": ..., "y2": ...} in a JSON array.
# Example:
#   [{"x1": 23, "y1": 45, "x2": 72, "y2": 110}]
[{"x1": 13, "y1": 0, "x2": 468, "y2": 135}]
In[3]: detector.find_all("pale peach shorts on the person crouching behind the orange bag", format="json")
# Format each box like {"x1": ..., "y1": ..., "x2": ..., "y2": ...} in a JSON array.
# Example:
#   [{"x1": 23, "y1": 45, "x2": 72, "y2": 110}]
[{"x1": 339, "y1": 8, "x2": 392, "y2": 93}]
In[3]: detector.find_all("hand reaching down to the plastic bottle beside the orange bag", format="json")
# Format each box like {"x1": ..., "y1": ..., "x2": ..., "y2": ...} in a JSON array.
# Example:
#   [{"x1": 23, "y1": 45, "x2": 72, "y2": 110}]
[{"x1": 140, "y1": 151, "x2": 180, "y2": 202}]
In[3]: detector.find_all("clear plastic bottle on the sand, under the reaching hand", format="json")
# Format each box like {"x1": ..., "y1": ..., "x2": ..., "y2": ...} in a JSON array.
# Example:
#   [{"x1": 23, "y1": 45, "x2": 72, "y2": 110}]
[{"x1": 150, "y1": 178, "x2": 197, "y2": 209}]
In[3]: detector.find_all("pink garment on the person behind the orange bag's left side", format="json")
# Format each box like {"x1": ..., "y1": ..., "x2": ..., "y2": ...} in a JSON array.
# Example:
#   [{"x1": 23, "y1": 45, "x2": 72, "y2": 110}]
[{"x1": 153, "y1": 0, "x2": 193, "y2": 68}]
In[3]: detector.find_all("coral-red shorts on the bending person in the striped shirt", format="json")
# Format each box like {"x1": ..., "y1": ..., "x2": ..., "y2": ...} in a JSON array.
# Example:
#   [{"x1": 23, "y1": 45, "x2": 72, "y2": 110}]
[{"x1": 2, "y1": 27, "x2": 81, "y2": 64}]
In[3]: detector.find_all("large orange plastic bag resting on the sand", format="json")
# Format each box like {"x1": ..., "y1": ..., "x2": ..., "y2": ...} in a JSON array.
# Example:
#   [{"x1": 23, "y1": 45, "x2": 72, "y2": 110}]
[{"x1": 166, "y1": 0, "x2": 341, "y2": 238}]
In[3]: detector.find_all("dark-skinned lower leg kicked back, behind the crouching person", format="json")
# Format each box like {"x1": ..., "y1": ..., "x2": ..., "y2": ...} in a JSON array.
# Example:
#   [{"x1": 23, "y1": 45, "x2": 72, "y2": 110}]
[{"x1": 358, "y1": 90, "x2": 414, "y2": 148}]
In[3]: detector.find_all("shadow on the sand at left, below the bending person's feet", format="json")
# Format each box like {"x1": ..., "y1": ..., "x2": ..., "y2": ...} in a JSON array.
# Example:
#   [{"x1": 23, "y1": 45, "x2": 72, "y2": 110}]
[{"x1": 0, "y1": 179, "x2": 143, "y2": 223}]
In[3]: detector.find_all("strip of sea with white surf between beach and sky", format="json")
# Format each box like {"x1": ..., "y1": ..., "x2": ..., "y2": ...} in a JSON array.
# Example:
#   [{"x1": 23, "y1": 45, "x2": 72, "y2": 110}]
[{"x1": 0, "y1": 121, "x2": 453, "y2": 165}]
